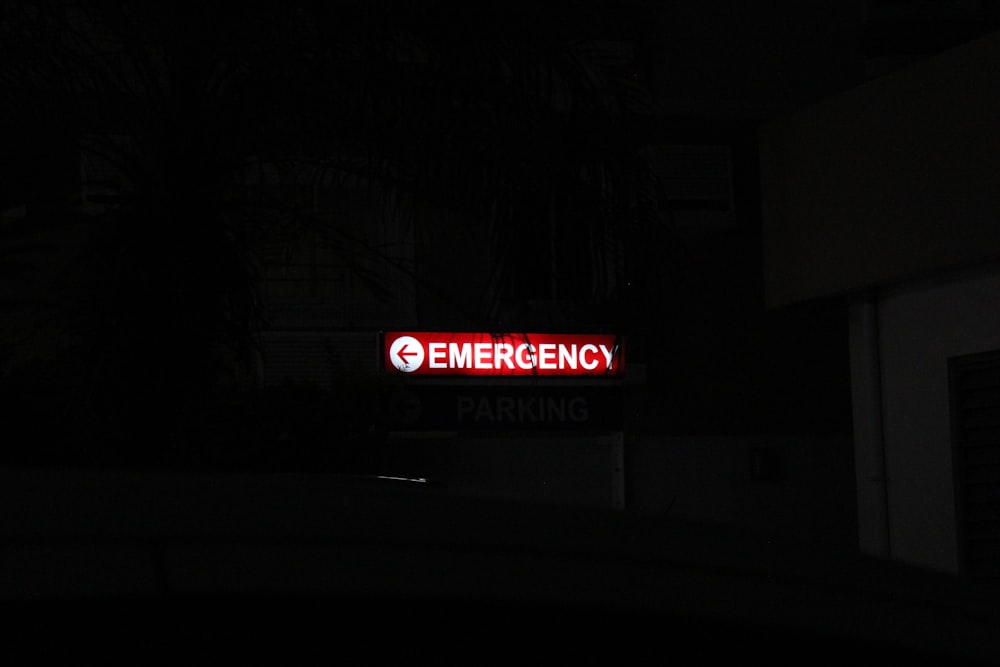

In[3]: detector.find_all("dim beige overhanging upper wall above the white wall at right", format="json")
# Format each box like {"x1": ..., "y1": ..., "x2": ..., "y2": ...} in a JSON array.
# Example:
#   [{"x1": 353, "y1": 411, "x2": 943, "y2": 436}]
[{"x1": 760, "y1": 33, "x2": 1000, "y2": 305}]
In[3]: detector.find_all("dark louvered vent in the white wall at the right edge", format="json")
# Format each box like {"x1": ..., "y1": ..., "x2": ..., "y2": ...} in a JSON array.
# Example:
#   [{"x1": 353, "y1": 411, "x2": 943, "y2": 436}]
[{"x1": 950, "y1": 351, "x2": 1000, "y2": 581}]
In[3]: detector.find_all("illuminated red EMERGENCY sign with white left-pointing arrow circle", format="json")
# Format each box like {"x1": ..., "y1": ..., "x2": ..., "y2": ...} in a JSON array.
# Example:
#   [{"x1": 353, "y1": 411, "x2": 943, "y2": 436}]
[{"x1": 385, "y1": 331, "x2": 625, "y2": 376}]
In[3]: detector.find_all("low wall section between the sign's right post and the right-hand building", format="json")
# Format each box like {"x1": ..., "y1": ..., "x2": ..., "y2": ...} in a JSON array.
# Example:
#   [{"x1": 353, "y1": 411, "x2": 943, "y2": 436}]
[{"x1": 626, "y1": 436, "x2": 858, "y2": 548}]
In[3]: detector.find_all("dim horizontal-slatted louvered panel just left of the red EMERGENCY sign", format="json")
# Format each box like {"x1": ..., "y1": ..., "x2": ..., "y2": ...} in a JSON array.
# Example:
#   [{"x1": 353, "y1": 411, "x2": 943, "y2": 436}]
[{"x1": 263, "y1": 331, "x2": 378, "y2": 389}]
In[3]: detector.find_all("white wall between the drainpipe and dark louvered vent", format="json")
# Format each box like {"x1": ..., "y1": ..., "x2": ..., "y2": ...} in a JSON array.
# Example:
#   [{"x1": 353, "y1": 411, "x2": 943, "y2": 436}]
[{"x1": 878, "y1": 265, "x2": 1000, "y2": 572}]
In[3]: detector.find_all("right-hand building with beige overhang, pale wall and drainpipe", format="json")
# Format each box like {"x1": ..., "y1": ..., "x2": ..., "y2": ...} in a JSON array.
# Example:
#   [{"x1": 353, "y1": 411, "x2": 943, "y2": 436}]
[{"x1": 761, "y1": 15, "x2": 1000, "y2": 572}]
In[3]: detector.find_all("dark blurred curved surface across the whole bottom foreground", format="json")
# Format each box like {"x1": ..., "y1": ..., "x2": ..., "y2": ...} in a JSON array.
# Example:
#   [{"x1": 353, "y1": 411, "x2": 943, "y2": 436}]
[{"x1": 0, "y1": 469, "x2": 1000, "y2": 665}]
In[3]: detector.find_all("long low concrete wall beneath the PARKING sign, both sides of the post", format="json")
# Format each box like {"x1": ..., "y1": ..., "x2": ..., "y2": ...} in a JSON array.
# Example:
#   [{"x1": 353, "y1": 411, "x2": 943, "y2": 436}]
[{"x1": 383, "y1": 432, "x2": 858, "y2": 550}]
